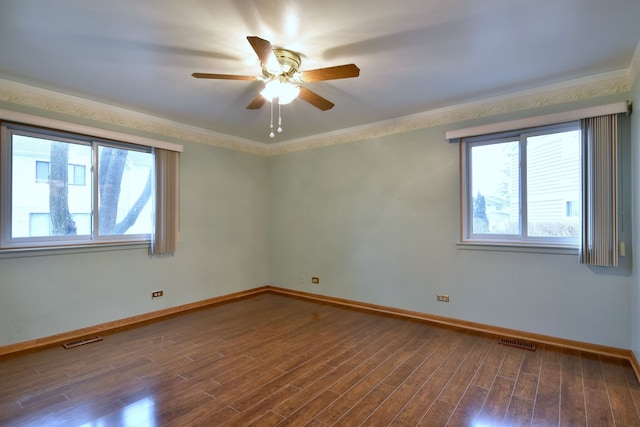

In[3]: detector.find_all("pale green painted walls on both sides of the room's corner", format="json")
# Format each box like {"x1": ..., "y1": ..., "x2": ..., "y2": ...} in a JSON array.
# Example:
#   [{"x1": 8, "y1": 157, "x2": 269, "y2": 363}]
[{"x1": 0, "y1": 90, "x2": 640, "y2": 351}]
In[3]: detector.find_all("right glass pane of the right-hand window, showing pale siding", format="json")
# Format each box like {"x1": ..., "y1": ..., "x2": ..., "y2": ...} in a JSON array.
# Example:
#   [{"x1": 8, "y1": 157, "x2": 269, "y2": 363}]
[{"x1": 527, "y1": 130, "x2": 580, "y2": 239}]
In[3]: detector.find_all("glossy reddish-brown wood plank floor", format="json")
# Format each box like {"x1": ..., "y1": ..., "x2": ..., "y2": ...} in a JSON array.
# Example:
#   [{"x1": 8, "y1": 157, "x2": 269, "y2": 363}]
[{"x1": 0, "y1": 294, "x2": 640, "y2": 427}]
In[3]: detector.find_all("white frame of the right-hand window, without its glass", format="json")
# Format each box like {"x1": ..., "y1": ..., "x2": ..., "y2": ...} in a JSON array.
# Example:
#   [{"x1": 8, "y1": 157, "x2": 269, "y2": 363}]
[{"x1": 459, "y1": 121, "x2": 582, "y2": 251}]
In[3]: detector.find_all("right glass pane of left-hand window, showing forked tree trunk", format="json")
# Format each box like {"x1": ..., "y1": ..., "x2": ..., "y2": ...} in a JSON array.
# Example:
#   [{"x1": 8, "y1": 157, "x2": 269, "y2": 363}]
[{"x1": 98, "y1": 145, "x2": 153, "y2": 236}]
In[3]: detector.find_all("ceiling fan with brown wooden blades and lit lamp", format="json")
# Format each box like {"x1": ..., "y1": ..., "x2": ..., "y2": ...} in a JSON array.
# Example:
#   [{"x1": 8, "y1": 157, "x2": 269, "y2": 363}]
[{"x1": 192, "y1": 36, "x2": 360, "y2": 111}]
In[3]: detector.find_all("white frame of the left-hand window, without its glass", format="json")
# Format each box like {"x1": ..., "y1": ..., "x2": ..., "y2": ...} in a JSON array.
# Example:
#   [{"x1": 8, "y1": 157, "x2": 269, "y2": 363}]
[{"x1": 0, "y1": 122, "x2": 155, "y2": 253}]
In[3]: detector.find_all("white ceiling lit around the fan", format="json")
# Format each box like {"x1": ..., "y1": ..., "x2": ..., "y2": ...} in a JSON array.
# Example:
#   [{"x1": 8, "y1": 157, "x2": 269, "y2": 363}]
[{"x1": 0, "y1": 0, "x2": 640, "y2": 143}]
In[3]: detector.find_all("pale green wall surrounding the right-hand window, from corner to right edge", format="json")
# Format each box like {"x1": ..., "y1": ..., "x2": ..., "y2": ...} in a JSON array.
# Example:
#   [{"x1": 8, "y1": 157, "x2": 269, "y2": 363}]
[{"x1": 270, "y1": 100, "x2": 631, "y2": 348}]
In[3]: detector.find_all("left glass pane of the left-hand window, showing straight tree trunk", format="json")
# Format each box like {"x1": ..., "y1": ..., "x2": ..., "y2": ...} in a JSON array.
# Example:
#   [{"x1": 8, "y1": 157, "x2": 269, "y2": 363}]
[{"x1": 11, "y1": 134, "x2": 91, "y2": 238}]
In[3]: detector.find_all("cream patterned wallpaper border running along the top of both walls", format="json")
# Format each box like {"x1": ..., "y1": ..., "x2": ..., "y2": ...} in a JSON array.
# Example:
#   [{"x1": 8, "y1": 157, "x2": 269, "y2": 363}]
[{"x1": 0, "y1": 43, "x2": 640, "y2": 156}]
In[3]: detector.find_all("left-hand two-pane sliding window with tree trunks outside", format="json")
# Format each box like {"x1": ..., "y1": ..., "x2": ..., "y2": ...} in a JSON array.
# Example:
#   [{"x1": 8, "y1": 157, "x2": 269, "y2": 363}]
[{"x1": 0, "y1": 125, "x2": 154, "y2": 249}]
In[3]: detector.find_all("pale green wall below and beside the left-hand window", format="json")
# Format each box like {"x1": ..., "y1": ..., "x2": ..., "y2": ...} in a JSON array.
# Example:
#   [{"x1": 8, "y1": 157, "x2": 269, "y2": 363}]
[{"x1": 0, "y1": 143, "x2": 268, "y2": 345}]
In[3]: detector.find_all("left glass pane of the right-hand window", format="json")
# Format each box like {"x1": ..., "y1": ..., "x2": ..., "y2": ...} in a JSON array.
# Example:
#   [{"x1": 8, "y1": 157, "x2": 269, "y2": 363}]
[{"x1": 470, "y1": 141, "x2": 520, "y2": 235}]
